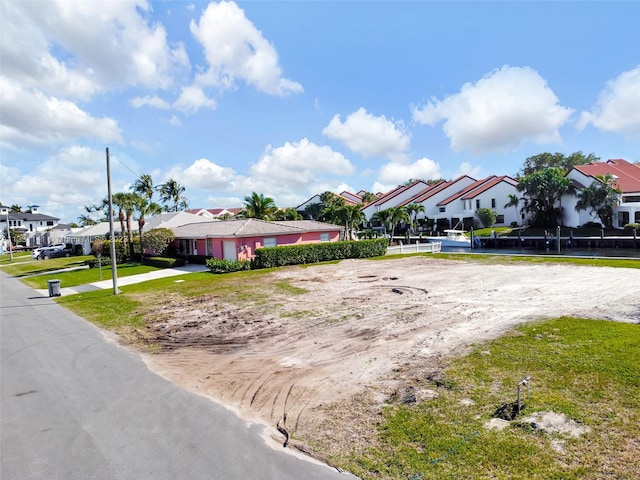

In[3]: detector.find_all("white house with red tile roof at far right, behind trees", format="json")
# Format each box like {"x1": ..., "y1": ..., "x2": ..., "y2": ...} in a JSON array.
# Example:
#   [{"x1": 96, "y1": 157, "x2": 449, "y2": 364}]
[{"x1": 562, "y1": 159, "x2": 640, "y2": 228}]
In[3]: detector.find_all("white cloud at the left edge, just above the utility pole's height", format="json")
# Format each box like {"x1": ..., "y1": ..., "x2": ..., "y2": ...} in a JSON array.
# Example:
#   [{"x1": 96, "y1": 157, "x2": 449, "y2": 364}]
[{"x1": 0, "y1": 78, "x2": 122, "y2": 145}]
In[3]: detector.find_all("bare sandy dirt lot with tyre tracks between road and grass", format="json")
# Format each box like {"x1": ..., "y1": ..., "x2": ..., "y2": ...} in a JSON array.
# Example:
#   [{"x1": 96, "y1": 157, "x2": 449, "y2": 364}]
[{"x1": 138, "y1": 257, "x2": 640, "y2": 458}]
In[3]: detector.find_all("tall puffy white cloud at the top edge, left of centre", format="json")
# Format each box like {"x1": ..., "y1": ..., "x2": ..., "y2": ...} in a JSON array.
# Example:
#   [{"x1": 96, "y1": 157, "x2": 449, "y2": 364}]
[{"x1": 191, "y1": 2, "x2": 303, "y2": 95}]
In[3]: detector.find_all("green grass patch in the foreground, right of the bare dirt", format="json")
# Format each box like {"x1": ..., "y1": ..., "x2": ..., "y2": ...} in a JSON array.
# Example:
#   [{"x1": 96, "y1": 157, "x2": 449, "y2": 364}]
[{"x1": 331, "y1": 318, "x2": 640, "y2": 480}]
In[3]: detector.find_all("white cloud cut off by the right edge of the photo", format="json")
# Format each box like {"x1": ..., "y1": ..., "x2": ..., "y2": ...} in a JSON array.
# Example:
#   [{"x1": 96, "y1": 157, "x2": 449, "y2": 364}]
[{"x1": 577, "y1": 66, "x2": 640, "y2": 135}]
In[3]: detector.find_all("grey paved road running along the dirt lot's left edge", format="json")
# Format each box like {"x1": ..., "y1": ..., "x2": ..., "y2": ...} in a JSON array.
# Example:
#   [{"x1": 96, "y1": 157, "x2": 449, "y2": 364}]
[{"x1": 0, "y1": 273, "x2": 353, "y2": 480}]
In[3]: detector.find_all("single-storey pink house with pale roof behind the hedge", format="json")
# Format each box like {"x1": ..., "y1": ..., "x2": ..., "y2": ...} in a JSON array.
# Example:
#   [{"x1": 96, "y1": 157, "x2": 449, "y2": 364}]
[{"x1": 171, "y1": 218, "x2": 343, "y2": 260}]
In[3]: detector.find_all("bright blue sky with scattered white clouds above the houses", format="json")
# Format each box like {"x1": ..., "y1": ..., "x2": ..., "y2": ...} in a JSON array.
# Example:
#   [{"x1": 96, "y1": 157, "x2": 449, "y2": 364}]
[{"x1": 0, "y1": 0, "x2": 640, "y2": 222}]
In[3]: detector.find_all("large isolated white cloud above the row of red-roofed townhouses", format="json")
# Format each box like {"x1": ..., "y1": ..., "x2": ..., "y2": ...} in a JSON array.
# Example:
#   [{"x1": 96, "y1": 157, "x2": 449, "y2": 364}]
[{"x1": 413, "y1": 66, "x2": 573, "y2": 153}]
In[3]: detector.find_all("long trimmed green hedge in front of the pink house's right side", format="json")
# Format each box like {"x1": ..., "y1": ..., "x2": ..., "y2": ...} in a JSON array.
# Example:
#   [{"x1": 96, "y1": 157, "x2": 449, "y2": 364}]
[{"x1": 251, "y1": 238, "x2": 389, "y2": 269}]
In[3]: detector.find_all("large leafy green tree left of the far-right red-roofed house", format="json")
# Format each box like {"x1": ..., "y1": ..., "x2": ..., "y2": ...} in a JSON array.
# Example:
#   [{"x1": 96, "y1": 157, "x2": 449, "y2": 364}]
[{"x1": 517, "y1": 168, "x2": 571, "y2": 227}]
